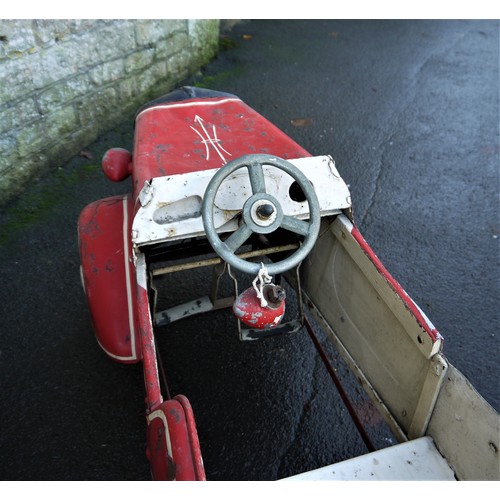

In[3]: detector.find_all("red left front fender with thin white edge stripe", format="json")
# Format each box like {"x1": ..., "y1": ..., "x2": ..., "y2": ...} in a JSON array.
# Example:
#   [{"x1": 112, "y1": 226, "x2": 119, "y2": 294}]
[{"x1": 78, "y1": 196, "x2": 142, "y2": 363}]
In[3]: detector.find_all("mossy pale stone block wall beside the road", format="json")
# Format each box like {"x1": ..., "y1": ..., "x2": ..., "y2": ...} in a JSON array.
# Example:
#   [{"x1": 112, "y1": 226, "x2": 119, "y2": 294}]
[{"x1": 0, "y1": 19, "x2": 219, "y2": 205}]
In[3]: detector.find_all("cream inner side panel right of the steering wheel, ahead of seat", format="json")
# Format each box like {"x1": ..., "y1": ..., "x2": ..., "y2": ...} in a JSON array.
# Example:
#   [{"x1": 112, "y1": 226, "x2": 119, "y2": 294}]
[{"x1": 301, "y1": 215, "x2": 446, "y2": 439}]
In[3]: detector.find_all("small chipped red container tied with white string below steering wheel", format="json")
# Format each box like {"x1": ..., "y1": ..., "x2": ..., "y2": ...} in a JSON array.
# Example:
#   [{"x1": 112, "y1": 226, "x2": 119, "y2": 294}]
[{"x1": 233, "y1": 284, "x2": 286, "y2": 330}]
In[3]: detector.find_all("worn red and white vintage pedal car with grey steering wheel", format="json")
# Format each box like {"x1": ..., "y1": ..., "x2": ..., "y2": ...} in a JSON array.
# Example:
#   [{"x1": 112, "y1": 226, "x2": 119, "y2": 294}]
[{"x1": 78, "y1": 87, "x2": 499, "y2": 480}]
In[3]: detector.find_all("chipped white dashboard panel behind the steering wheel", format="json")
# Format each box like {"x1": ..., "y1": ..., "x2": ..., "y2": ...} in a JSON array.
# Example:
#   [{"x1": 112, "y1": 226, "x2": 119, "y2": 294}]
[{"x1": 132, "y1": 156, "x2": 351, "y2": 246}]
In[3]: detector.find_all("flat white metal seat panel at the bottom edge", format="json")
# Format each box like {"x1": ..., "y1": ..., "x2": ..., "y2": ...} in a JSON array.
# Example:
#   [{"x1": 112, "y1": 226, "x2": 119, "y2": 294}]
[{"x1": 284, "y1": 436, "x2": 455, "y2": 481}]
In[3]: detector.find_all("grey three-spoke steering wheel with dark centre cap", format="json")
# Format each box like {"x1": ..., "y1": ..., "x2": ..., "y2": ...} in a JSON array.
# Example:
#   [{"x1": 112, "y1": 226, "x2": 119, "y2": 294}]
[{"x1": 201, "y1": 154, "x2": 321, "y2": 275}]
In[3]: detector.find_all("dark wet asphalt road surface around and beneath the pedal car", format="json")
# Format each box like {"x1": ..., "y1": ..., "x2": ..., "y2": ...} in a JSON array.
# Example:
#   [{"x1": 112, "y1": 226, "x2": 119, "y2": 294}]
[{"x1": 0, "y1": 20, "x2": 500, "y2": 480}]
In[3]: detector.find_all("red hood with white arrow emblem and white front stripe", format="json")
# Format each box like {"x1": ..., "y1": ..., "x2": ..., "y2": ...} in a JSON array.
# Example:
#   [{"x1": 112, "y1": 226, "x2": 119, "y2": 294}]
[{"x1": 133, "y1": 98, "x2": 311, "y2": 198}]
